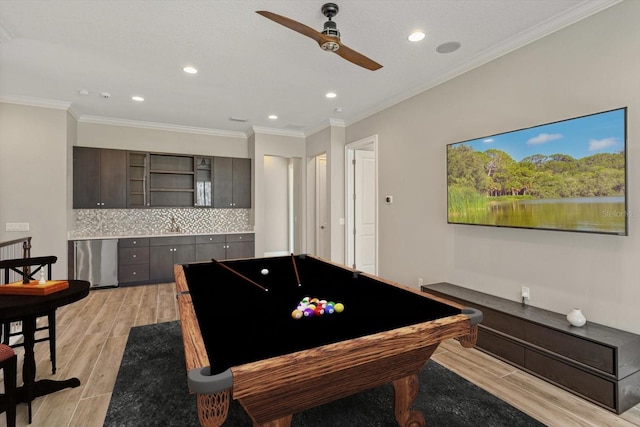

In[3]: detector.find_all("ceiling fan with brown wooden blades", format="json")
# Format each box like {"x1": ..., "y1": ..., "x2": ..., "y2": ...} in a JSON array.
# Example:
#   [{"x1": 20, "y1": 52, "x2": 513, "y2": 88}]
[{"x1": 256, "y1": 3, "x2": 382, "y2": 71}]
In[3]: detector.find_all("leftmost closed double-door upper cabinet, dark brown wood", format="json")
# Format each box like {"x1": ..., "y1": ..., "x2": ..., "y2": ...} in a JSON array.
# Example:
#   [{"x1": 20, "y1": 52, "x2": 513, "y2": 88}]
[{"x1": 73, "y1": 147, "x2": 127, "y2": 209}]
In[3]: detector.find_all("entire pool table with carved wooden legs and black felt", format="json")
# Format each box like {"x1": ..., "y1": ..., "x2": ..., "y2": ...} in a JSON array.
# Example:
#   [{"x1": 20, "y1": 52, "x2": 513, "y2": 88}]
[{"x1": 174, "y1": 255, "x2": 482, "y2": 427}]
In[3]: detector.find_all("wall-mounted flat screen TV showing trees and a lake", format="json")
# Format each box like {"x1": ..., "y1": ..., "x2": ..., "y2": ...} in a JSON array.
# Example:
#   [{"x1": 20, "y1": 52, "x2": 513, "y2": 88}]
[{"x1": 447, "y1": 107, "x2": 628, "y2": 236}]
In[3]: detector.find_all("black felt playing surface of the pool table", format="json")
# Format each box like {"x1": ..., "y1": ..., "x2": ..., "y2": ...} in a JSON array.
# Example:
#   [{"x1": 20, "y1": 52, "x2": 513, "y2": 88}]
[{"x1": 184, "y1": 255, "x2": 461, "y2": 373}]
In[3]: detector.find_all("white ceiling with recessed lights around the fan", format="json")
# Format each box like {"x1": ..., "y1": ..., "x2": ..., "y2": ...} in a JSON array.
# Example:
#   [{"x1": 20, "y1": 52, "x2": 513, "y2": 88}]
[{"x1": 0, "y1": 0, "x2": 619, "y2": 135}]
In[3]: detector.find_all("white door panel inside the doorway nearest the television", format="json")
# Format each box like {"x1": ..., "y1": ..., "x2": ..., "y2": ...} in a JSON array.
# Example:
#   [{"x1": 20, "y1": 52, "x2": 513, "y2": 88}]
[{"x1": 354, "y1": 150, "x2": 376, "y2": 274}]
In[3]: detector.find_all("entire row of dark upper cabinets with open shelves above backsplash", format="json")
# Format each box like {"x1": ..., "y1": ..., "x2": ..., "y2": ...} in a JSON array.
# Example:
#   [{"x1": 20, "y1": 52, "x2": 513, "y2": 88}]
[{"x1": 73, "y1": 147, "x2": 251, "y2": 209}]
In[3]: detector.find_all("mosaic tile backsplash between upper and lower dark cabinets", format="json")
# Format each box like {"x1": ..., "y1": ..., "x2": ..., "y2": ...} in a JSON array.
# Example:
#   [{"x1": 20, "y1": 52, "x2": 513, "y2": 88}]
[{"x1": 69, "y1": 208, "x2": 253, "y2": 238}]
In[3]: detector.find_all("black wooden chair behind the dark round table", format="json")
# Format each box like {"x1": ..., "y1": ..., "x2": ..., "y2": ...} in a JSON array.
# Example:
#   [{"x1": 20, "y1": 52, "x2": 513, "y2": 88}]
[{"x1": 0, "y1": 256, "x2": 58, "y2": 374}]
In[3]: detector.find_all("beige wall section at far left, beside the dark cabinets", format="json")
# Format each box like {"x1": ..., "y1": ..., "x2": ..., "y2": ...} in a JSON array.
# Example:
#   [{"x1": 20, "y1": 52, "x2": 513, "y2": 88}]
[{"x1": 0, "y1": 103, "x2": 73, "y2": 277}]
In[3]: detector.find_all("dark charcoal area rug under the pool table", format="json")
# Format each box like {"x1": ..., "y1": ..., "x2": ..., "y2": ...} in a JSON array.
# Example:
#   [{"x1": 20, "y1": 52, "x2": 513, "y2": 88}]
[{"x1": 104, "y1": 322, "x2": 543, "y2": 427}]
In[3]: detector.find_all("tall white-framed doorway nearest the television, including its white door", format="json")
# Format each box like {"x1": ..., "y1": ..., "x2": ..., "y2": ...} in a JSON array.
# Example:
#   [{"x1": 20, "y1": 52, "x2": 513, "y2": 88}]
[{"x1": 345, "y1": 135, "x2": 378, "y2": 275}]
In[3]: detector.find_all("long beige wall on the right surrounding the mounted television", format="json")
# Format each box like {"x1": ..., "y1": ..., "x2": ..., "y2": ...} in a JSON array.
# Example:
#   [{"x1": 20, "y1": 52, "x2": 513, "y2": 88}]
[{"x1": 347, "y1": 1, "x2": 640, "y2": 333}]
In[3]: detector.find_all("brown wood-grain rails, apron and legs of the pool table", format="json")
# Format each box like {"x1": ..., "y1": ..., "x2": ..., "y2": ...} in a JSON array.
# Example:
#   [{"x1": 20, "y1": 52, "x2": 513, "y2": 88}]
[{"x1": 175, "y1": 265, "x2": 481, "y2": 427}]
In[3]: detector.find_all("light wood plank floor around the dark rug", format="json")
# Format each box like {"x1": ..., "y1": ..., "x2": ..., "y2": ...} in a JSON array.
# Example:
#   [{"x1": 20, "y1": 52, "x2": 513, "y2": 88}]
[{"x1": 0, "y1": 283, "x2": 640, "y2": 427}]
